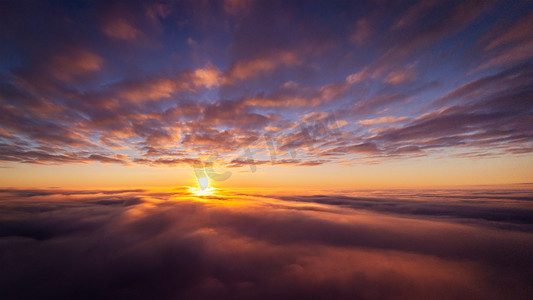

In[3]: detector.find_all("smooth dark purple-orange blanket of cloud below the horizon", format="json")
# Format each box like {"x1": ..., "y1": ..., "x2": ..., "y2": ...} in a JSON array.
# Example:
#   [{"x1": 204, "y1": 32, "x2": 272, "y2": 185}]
[{"x1": 0, "y1": 188, "x2": 533, "y2": 299}]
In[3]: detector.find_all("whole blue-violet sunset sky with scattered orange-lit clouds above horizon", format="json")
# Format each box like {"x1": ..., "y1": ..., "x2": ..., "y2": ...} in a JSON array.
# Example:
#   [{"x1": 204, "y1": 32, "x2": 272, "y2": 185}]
[{"x1": 0, "y1": 0, "x2": 533, "y2": 188}]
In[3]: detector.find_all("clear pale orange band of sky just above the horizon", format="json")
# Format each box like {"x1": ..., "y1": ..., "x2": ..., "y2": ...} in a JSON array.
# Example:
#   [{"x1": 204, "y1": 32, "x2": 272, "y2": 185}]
[{"x1": 0, "y1": 152, "x2": 533, "y2": 189}]
